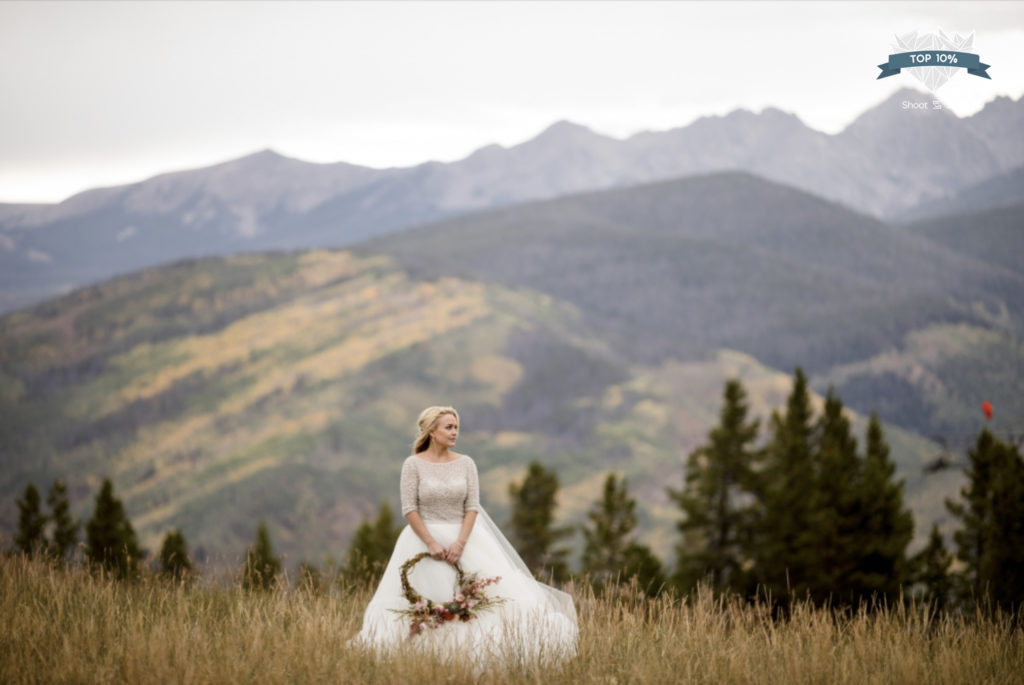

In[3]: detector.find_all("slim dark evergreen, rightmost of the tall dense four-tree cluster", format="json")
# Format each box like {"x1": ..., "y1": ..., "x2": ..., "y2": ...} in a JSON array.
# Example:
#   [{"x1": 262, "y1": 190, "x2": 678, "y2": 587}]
[{"x1": 851, "y1": 414, "x2": 913, "y2": 600}]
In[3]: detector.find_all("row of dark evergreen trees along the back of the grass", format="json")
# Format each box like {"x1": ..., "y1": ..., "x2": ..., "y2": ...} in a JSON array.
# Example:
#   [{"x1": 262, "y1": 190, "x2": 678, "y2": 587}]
[{"x1": 14, "y1": 369, "x2": 1024, "y2": 610}]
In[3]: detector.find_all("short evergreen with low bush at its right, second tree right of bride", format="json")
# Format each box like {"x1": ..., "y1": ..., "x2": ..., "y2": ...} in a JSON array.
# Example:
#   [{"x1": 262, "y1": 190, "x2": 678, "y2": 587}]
[{"x1": 582, "y1": 473, "x2": 665, "y2": 596}]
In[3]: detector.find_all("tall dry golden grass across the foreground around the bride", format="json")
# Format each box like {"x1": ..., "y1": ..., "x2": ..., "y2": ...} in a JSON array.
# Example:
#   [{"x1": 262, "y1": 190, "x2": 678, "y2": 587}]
[{"x1": 0, "y1": 557, "x2": 1024, "y2": 685}]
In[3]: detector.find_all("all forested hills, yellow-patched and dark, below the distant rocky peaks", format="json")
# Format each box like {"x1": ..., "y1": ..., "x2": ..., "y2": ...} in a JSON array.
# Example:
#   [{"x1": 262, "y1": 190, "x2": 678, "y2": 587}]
[{"x1": 0, "y1": 166, "x2": 1024, "y2": 564}]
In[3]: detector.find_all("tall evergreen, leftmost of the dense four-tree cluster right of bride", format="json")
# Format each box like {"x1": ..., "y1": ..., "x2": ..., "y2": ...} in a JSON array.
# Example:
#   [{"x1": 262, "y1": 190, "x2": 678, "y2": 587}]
[{"x1": 669, "y1": 380, "x2": 759, "y2": 592}]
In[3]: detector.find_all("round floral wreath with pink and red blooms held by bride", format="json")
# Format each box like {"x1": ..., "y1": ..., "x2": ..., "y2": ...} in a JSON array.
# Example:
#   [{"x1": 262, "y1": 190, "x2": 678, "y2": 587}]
[{"x1": 391, "y1": 552, "x2": 505, "y2": 637}]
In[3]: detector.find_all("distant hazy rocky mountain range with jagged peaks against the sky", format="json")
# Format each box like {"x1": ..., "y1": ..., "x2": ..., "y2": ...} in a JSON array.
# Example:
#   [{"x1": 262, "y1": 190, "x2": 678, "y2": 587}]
[{"x1": 0, "y1": 84, "x2": 1024, "y2": 311}]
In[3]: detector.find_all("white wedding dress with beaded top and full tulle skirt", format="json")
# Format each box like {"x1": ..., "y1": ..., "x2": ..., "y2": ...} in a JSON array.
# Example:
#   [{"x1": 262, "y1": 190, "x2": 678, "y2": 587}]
[{"x1": 353, "y1": 456, "x2": 579, "y2": 663}]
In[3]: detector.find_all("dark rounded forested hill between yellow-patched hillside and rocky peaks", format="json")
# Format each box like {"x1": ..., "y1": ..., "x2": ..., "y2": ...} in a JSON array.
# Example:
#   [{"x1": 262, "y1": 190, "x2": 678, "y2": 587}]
[{"x1": 358, "y1": 173, "x2": 1024, "y2": 372}]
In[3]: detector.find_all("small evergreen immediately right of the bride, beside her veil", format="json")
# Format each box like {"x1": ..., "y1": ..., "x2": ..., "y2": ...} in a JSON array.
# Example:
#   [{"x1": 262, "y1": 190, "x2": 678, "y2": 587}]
[{"x1": 509, "y1": 462, "x2": 572, "y2": 581}]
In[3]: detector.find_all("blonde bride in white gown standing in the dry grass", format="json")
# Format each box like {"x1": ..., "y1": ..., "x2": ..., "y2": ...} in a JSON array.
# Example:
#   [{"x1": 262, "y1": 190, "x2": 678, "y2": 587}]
[{"x1": 354, "y1": 406, "x2": 578, "y2": 662}]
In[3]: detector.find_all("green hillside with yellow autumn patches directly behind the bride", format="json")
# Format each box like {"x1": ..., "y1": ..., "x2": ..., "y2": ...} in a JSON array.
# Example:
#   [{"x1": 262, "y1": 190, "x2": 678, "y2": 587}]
[{"x1": 0, "y1": 246, "x2": 955, "y2": 565}]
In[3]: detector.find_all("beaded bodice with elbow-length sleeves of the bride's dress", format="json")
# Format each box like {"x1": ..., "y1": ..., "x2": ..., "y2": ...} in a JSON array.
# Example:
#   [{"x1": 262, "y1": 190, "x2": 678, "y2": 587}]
[{"x1": 401, "y1": 455, "x2": 480, "y2": 521}]
